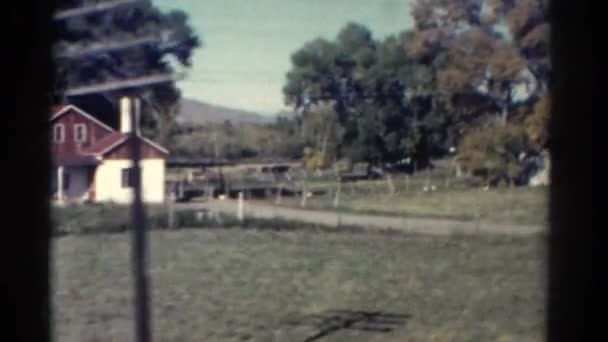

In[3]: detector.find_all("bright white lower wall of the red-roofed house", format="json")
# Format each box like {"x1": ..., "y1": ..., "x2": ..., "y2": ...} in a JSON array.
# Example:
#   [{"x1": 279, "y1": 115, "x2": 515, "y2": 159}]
[{"x1": 95, "y1": 159, "x2": 165, "y2": 204}]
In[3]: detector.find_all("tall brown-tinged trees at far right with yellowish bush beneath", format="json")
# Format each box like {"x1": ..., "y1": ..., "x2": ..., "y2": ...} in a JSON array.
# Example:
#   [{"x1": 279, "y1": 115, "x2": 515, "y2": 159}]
[{"x1": 406, "y1": 0, "x2": 550, "y2": 183}]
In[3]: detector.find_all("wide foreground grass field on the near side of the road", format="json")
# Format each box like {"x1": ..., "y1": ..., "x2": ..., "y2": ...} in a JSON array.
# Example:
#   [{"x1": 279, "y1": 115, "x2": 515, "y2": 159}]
[{"x1": 53, "y1": 229, "x2": 545, "y2": 342}]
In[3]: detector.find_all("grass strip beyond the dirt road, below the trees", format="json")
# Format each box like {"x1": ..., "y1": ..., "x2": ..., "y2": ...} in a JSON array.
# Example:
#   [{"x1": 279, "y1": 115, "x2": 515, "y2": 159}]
[{"x1": 283, "y1": 173, "x2": 548, "y2": 224}]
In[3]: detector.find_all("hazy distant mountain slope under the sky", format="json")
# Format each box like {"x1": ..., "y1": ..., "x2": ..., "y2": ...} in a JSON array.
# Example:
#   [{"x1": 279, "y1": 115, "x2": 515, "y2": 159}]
[{"x1": 177, "y1": 98, "x2": 275, "y2": 124}]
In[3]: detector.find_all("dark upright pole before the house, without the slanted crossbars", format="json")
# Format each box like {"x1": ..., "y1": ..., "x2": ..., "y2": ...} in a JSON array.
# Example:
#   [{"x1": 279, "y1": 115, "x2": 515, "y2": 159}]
[{"x1": 122, "y1": 98, "x2": 151, "y2": 342}]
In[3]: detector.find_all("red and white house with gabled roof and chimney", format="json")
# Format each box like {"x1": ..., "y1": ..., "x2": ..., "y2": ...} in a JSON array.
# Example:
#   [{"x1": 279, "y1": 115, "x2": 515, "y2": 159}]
[{"x1": 51, "y1": 101, "x2": 169, "y2": 204}]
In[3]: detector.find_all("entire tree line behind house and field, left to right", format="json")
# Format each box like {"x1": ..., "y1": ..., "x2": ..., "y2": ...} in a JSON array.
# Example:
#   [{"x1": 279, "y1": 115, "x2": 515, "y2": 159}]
[{"x1": 56, "y1": 0, "x2": 551, "y2": 184}]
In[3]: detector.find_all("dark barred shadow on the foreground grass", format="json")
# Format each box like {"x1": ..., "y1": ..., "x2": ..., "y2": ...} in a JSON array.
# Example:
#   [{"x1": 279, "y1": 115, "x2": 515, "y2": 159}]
[{"x1": 285, "y1": 310, "x2": 412, "y2": 342}]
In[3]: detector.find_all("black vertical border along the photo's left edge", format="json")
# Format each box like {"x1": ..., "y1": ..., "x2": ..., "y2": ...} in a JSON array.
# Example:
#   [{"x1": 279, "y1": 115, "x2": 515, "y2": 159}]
[{"x1": 8, "y1": 1, "x2": 54, "y2": 342}]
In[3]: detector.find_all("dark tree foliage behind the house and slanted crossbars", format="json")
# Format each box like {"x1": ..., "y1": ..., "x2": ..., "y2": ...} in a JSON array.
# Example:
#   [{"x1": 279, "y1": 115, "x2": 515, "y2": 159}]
[{"x1": 55, "y1": 0, "x2": 200, "y2": 144}]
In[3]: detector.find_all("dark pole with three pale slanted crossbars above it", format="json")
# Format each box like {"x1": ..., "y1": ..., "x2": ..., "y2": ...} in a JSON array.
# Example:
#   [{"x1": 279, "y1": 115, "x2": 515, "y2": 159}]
[{"x1": 53, "y1": 0, "x2": 196, "y2": 342}]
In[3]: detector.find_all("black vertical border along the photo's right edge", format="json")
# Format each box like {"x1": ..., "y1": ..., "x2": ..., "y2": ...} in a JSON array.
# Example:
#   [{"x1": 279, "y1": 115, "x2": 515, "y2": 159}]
[{"x1": 546, "y1": 1, "x2": 608, "y2": 342}]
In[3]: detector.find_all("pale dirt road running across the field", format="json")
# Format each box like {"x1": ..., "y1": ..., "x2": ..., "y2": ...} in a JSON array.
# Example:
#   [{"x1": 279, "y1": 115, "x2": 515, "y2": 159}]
[{"x1": 177, "y1": 200, "x2": 546, "y2": 235}]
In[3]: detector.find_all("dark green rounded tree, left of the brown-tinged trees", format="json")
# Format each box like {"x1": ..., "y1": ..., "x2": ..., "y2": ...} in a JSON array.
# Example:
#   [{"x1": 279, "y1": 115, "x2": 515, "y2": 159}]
[{"x1": 284, "y1": 23, "x2": 430, "y2": 162}]
